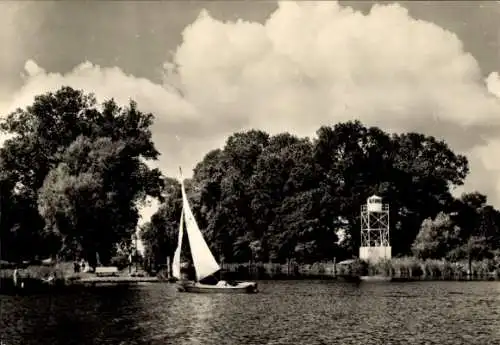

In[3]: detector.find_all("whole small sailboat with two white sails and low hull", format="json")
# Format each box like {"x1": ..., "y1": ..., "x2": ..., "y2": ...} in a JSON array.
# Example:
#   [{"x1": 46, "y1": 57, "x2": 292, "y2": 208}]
[{"x1": 172, "y1": 172, "x2": 258, "y2": 293}]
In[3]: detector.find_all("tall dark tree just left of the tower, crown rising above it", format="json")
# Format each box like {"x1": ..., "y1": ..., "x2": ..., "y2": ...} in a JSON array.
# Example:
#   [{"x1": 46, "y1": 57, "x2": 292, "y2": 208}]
[{"x1": 314, "y1": 121, "x2": 393, "y2": 249}]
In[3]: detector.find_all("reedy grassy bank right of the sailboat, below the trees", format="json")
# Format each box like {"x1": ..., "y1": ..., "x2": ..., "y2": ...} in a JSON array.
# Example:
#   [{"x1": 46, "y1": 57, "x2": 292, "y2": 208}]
[{"x1": 222, "y1": 257, "x2": 500, "y2": 280}]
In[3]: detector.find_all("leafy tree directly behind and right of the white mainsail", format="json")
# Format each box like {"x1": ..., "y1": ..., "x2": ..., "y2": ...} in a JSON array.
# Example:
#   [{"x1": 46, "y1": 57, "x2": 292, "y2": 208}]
[{"x1": 192, "y1": 130, "x2": 269, "y2": 261}]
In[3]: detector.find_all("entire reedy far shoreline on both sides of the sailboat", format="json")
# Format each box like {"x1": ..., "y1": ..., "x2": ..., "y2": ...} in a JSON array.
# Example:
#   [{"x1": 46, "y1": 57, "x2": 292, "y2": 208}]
[{"x1": 0, "y1": 257, "x2": 500, "y2": 293}]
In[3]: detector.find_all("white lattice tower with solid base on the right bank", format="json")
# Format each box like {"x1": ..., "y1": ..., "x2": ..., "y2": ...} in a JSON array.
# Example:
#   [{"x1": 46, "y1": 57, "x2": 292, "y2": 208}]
[{"x1": 359, "y1": 195, "x2": 392, "y2": 262}]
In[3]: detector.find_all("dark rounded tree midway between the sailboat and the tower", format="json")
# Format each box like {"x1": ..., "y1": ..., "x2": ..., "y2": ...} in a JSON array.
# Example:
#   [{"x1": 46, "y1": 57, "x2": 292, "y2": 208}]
[{"x1": 252, "y1": 133, "x2": 337, "y2": 261}]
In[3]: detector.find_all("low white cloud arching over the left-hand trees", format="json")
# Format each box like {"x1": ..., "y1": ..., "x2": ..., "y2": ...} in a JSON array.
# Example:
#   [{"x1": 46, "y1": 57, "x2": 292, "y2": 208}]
[{"x1": 6, "y1": 60, "x2": 205, "y2": 175}]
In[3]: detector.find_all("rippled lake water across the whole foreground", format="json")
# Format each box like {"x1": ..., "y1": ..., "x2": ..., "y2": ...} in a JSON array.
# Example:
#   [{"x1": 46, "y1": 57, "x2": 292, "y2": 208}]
[{"x1": 0, "y1": 281, "x2": 500, "y2": 345}]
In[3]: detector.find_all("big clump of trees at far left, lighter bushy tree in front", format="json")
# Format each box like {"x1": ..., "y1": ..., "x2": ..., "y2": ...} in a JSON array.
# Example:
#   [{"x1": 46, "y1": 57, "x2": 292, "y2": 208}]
[{"x1": 0, "y1": 87, "x2": 163, "y2": 265}]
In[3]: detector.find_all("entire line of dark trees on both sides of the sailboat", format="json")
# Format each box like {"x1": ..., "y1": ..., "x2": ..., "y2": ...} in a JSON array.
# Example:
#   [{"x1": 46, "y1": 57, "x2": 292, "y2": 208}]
[{"x1": 0, "y1": 87, "x2": 500, "y2": 265}]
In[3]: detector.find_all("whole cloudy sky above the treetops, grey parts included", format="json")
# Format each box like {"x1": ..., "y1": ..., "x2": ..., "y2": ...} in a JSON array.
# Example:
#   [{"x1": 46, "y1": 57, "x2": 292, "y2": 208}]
[{"x1": 0, "y1": 1, "x2": 500, "y2": 226}]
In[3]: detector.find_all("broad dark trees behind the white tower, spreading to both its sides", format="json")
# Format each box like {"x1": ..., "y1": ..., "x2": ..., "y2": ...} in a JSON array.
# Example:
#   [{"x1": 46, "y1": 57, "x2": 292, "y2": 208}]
[{"x1": 314, "y1": 121, "x2": 468, "y2": 254}]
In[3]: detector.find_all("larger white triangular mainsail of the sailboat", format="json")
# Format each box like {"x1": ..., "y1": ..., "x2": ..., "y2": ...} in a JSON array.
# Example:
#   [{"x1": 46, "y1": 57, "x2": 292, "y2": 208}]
[{"x1": 181, "y1": 180, "x2": 220, "y2": 281}]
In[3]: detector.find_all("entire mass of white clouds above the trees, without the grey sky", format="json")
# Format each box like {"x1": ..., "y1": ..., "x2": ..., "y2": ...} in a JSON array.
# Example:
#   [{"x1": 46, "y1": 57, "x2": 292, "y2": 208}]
[{"x1": 0, "y1": 2, "x2": 500, "y2": 219}]
